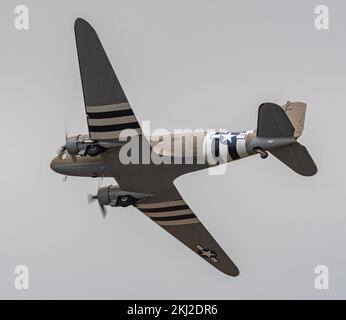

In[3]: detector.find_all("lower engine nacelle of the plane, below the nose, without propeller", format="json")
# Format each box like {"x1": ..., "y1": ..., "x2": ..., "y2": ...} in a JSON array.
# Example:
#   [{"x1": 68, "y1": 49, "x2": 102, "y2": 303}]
[{"x1": 97, "y1": 185, "x2": 151, "y2": 207}]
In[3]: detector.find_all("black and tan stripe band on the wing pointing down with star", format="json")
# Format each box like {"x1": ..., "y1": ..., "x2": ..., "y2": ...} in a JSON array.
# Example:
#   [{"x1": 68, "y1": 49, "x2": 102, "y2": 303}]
[{"x1": 137, "y1": 200, "x2": 200, "y2": 226}]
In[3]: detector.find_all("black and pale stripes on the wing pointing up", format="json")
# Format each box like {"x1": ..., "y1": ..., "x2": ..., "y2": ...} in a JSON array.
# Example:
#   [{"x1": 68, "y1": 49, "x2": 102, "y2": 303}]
[{"x1": 86, "y1": 102, "x2": 142, "y2": 140}]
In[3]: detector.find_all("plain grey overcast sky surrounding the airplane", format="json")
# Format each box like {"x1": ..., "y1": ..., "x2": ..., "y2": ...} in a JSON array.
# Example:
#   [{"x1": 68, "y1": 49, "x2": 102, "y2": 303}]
[{"x1": 0, "y1": 0, "x2": 346, "y2": 299}]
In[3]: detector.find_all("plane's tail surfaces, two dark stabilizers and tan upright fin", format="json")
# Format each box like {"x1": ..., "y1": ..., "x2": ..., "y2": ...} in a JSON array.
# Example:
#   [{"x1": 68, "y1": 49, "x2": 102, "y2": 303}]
[{"x1": 257, "y1": 102, "x2": 317, "y2": 176}]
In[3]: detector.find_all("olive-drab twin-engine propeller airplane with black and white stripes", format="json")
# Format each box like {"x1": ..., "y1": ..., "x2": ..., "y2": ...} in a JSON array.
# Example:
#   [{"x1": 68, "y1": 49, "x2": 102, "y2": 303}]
[{"x1": 50, "y1": 18, "x2": 317, "y2": 277}]
